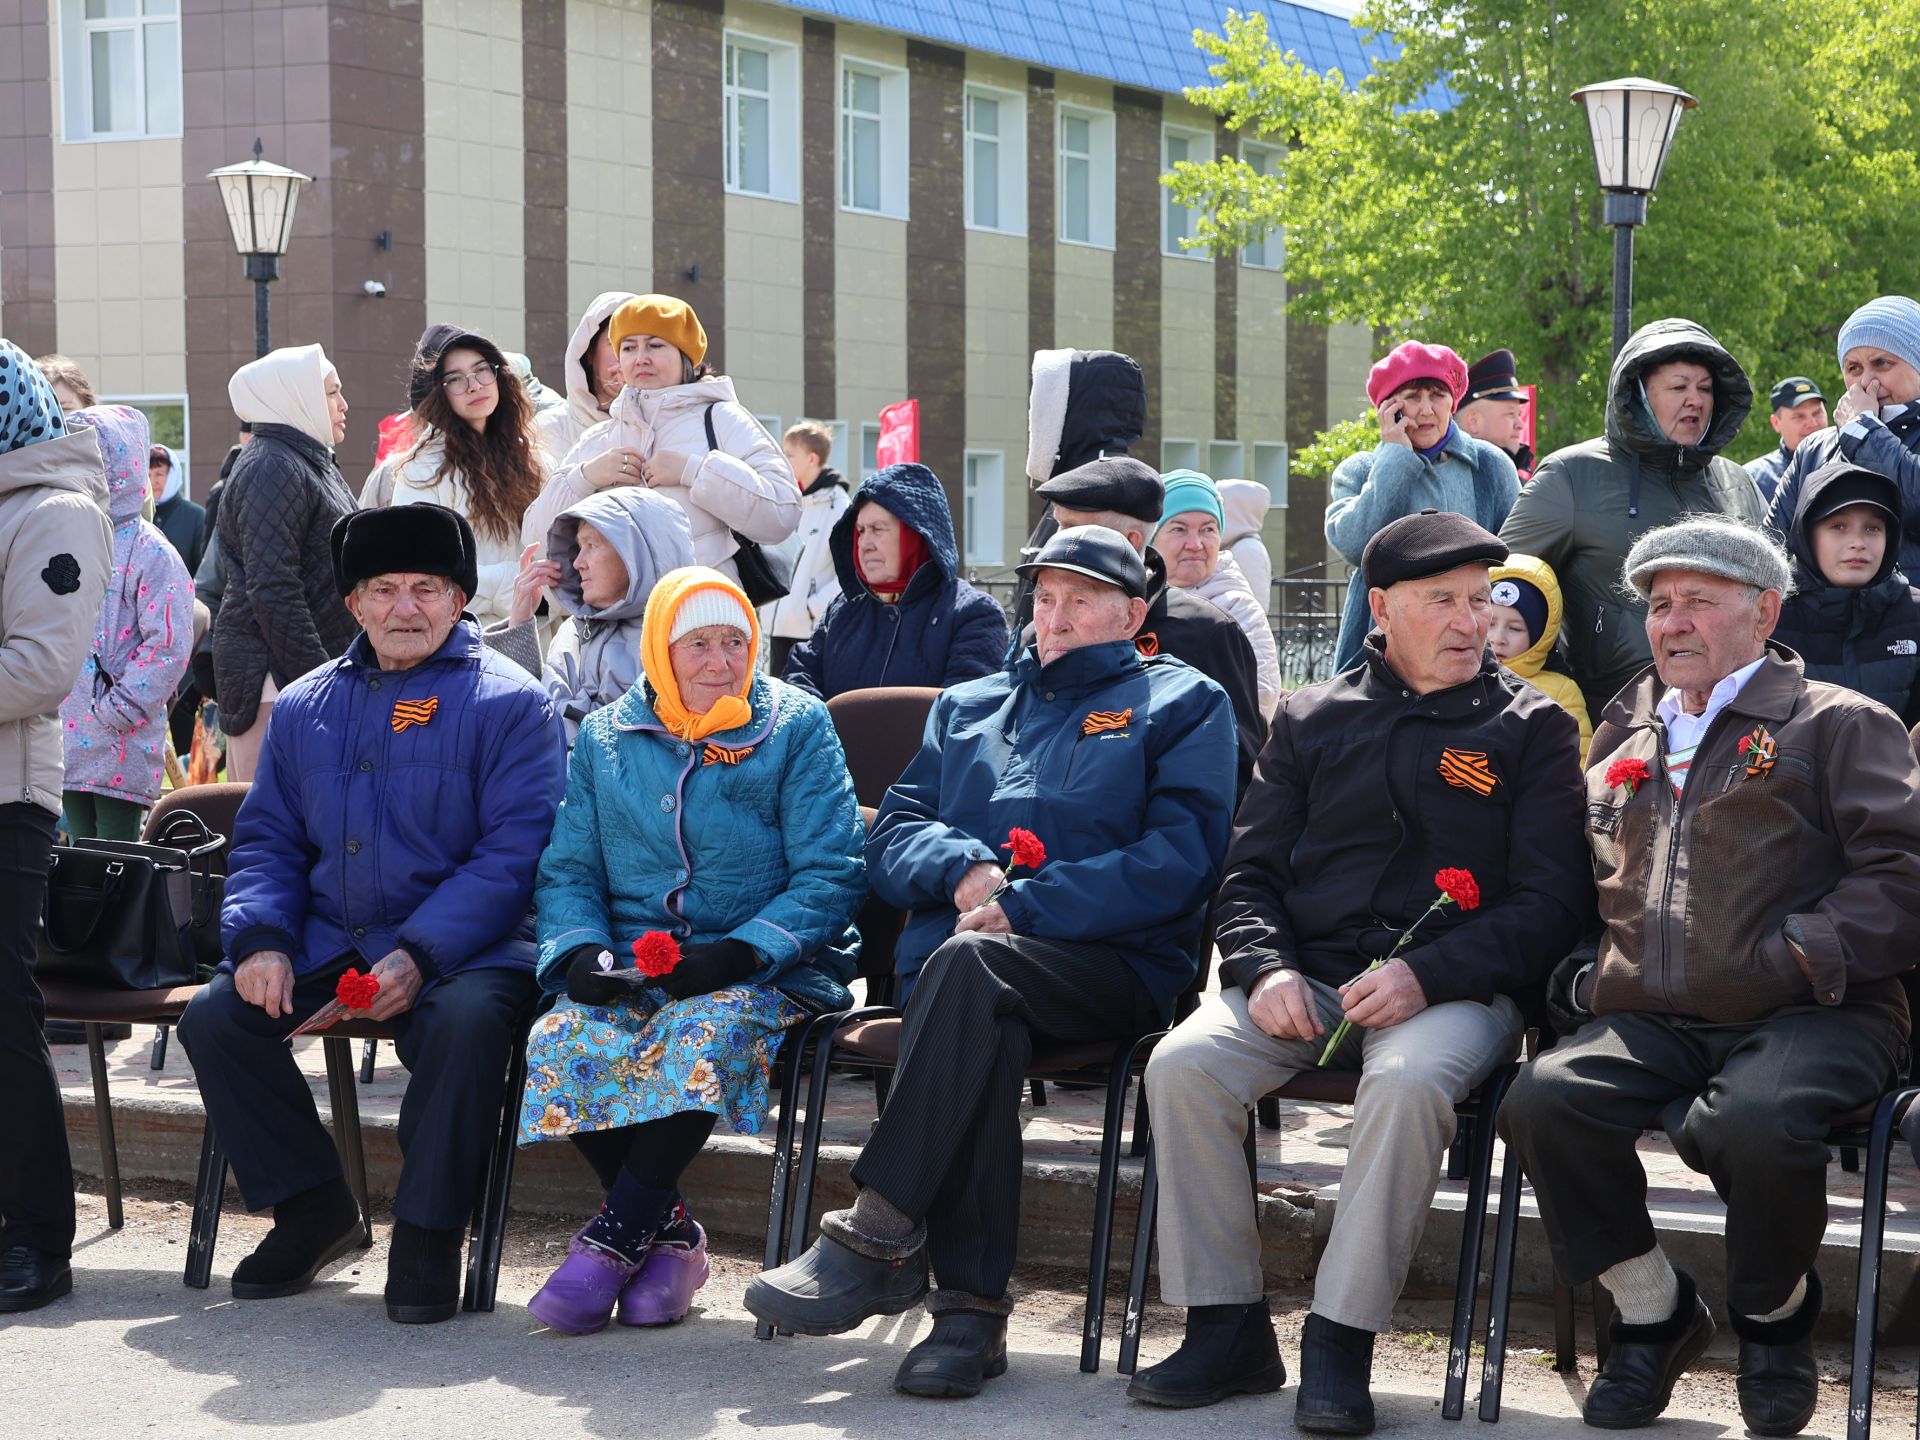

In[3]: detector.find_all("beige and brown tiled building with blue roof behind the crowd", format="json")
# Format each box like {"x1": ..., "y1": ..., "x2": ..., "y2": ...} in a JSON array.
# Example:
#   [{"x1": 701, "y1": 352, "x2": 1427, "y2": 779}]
[{"x1": 0, "y1": 0, "x2": 1369, "y2": 572}]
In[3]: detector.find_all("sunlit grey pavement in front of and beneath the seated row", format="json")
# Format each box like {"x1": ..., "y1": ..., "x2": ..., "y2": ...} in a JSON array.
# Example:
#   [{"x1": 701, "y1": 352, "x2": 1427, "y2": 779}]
[{"x1": 0, "y1": 1190, "x2": 1914, "y2": 1440}]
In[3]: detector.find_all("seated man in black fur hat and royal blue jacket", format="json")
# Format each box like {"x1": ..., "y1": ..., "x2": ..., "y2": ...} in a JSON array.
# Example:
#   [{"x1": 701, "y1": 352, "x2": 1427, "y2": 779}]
[{"x1": 180, "y1": 505, "x2": 566, "y2": 1323}]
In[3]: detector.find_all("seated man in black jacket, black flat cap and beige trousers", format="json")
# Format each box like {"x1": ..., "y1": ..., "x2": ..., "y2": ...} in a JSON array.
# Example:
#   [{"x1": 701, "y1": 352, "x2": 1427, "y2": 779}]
[{"x1": 1127, "y1": 511, "x2": 1594, "y2": 1434}]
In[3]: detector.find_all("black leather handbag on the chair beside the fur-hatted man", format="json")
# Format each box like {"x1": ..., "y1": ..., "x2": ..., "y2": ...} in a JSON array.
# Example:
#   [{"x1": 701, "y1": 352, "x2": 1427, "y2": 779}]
[{"x1": 33, "y1": 810, "x2": 227, "y2": 991}]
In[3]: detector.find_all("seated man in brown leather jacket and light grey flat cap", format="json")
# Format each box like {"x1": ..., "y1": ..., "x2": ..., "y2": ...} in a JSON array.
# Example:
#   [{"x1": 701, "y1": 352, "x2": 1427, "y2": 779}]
[{"x1": 1500, "y1": 516, "x2": 1920, "y2": 1434}]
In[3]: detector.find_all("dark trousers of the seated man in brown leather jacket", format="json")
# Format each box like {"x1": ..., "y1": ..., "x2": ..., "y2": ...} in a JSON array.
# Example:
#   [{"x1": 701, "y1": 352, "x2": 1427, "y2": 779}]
[{"x1": 1500, "y1": 1006, "x2": 1907, "y2": 1315}]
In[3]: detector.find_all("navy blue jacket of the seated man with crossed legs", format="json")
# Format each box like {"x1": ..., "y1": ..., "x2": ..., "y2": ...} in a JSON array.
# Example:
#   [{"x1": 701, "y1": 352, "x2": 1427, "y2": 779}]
[{"x1": 866, "y1": 639, "x2": 1238, "y2": 1014}]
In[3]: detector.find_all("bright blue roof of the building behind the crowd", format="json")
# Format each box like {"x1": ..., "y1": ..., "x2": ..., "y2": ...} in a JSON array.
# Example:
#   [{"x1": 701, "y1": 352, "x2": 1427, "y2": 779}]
[{"x1": 771, "y1": 0, "x2": 1392, "y2": 94}]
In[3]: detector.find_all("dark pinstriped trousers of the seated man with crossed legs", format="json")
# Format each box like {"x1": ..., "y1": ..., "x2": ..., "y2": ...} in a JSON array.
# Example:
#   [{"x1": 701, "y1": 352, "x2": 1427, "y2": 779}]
[{"x1": 852, "y1": 931, "x2": 1164, "y2": 1300}]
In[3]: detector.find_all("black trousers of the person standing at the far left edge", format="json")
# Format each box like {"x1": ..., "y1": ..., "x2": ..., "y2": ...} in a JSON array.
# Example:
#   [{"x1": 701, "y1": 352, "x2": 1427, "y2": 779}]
[{"x1": 0, "y1": 803, "x2": 73, "y2": 1260}]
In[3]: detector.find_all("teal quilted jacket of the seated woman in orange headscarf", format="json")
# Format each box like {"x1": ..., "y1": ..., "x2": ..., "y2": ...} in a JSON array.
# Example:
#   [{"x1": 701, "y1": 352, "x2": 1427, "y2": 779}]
[{"x1": 538, "y1": 676, "x2": 866, "y2": 1010}]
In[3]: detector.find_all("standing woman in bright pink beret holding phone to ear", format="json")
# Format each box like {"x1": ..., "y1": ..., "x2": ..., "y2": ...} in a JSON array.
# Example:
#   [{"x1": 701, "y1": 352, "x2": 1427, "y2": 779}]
[{"x1": 1327, "y1": 340, "x2": 1521, "y2": 670}]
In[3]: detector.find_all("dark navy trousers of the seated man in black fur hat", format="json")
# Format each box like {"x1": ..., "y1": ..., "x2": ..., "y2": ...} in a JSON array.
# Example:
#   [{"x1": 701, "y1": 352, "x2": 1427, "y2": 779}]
[{"x1": 180, "y1": 956, "x2": 536, "y2": 1231}]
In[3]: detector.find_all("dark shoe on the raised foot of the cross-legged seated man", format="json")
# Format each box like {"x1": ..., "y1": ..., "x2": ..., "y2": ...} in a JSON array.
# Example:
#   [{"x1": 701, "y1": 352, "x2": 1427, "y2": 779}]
[{"x1": 743, "y1": 1210, "x2": 927, "y2": 1334}]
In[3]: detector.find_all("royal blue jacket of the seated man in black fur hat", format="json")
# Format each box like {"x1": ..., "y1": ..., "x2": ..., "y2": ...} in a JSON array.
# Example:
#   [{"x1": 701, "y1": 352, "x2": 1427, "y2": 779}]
[{"x1": 221, "y1": 620, "x2": 566, "y2": 981}]
